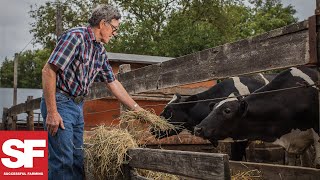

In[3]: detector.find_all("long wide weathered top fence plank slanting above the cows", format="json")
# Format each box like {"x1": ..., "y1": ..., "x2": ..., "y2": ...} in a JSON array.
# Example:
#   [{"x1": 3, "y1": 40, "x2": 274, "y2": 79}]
[{"x1": 114, "y1": 21, "x2": 309, "y2": 93}]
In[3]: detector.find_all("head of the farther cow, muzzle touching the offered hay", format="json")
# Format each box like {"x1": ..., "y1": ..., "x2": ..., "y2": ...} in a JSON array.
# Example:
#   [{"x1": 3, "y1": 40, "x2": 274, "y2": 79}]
[{"x1": 151, "y1": 94, "x2": 199, "y2": 139}]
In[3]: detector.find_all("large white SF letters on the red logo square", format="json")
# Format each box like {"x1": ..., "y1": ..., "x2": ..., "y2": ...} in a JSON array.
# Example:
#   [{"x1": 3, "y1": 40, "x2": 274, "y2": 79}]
[{"x1": 1, "y1": 139, "x2": 46, "y2": 168}]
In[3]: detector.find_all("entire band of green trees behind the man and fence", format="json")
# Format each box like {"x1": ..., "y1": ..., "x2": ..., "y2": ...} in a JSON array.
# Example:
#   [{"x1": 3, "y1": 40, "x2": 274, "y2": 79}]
[{"x1": 30, "y1": 0, "x2": 296, "y2": 57}]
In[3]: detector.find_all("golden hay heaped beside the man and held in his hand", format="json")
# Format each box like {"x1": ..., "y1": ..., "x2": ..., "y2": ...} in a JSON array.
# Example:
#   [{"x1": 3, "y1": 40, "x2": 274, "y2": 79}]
[{"x1": 85, "y1": 111, "x2": 178, "y2": 180}]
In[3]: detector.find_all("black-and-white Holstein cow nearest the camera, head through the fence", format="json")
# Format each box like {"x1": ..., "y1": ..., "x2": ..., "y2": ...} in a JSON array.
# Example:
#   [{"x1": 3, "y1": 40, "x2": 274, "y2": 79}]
[{"x1": 194, "y1": 67, "x2": 320, "y2": 168}]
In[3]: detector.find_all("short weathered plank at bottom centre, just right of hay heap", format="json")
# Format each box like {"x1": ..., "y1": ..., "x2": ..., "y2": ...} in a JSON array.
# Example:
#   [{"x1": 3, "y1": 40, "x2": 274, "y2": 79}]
[{"x1": 128, "y1": 148, "x2": 230, "y2": 179}]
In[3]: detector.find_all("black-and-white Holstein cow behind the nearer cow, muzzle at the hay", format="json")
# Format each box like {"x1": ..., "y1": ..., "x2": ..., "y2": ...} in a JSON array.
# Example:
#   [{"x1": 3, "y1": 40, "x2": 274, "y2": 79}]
[{"x1": 153, "y1": 74, "x2": 274, "y2": 160}]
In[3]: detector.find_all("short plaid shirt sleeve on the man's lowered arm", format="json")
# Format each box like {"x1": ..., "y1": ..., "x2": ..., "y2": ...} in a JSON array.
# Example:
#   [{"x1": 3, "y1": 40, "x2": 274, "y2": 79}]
[{"x1": 48, "y1": 33, "x2": 80, "y2": 71}]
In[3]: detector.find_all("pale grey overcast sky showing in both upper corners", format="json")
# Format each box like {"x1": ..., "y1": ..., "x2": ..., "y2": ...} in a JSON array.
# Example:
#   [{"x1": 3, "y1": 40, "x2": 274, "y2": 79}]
[{"x1": 0, "y1": 0, "x2": 316, "y2": 66}]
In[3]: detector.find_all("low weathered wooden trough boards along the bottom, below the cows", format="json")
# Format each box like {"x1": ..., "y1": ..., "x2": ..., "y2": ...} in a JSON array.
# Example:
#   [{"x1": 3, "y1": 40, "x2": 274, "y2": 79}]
[{"x1": 120, "y1": 148, "x2": 320, "y2": 180}]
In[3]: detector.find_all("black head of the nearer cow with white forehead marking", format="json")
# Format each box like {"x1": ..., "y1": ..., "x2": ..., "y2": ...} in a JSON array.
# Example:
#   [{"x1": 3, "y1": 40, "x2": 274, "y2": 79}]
[{"x1": 194, "y1": 98, "x2": 247, "y2": 144}]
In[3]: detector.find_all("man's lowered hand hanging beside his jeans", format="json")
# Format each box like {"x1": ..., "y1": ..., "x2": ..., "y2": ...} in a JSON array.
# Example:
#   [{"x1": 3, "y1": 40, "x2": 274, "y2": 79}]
[{"x1": 46, "y1": 112, "x2": 64, "y2": 136}]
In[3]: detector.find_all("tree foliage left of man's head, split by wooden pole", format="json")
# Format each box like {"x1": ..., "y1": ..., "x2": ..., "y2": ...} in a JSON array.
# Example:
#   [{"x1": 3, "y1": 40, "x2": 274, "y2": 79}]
[{"x1": 29, "y1": 0, "x2": 109, "y2": 49}]
